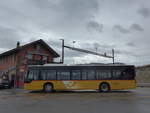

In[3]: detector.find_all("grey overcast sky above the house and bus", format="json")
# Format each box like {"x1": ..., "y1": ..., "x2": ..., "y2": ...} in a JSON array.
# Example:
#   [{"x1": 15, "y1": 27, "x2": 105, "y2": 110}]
[{"x1": 0, "y1": 0, "x2": 150, "y2": 65}]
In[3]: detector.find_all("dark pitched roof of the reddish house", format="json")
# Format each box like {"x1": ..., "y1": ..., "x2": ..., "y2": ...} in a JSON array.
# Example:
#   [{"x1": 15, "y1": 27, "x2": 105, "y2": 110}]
[{"x1": 0, "y1": 39, "x2": 60, "y2": 57}]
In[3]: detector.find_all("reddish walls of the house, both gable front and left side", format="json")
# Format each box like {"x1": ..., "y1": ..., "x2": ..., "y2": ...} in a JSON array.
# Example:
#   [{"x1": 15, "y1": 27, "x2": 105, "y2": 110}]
[{"x1": 0, "y1": 43, "x2": 57, "y2": 87}]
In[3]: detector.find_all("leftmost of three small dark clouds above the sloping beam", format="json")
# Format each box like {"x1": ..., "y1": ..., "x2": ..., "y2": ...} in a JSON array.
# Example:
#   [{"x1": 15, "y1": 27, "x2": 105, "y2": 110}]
[{"x1": 87, "y1": 21, "x2": 103, "y2": 33}]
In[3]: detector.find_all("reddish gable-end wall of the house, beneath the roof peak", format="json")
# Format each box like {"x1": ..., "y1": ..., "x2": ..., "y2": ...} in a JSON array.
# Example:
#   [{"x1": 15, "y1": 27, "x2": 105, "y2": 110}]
[{"x1": 16, "y1": 44, "x2": 53, "y2": 87}]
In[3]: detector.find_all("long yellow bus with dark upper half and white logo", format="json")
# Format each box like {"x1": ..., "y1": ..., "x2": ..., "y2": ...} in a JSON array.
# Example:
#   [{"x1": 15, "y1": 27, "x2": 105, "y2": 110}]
[{"x1": 24, "y1": 64, "x2": 136, "y2": 92}]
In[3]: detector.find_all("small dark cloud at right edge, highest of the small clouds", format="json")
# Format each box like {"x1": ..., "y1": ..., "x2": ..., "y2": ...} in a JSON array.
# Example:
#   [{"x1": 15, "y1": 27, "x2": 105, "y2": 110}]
[{"x1": 137, "y1": 7, "x2": 150, "y2": 18}]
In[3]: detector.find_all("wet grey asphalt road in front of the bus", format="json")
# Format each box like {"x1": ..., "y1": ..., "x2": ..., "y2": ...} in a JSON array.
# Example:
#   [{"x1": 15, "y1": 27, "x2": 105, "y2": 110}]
[{"x1": 0, "y1": 88, "x2": 150, "y2": 113}]
